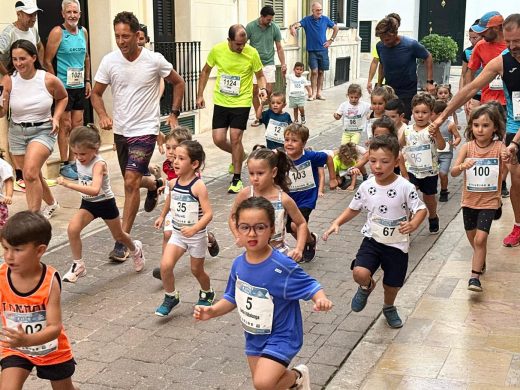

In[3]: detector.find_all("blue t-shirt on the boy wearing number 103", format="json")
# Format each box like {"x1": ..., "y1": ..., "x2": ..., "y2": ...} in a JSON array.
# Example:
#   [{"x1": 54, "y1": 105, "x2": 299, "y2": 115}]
[{"x1": 289, "y1": 150, "x2": 328, "y2": 209}]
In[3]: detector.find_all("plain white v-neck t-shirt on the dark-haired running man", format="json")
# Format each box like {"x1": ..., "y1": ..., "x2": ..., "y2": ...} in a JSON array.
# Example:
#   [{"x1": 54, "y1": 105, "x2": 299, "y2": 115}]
[{"x1": 95, "y1": 48, "x2": 173, "y2": 137}]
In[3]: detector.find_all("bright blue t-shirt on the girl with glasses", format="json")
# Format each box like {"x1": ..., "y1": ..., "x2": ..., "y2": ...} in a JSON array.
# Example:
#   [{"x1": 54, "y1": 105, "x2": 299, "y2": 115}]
[{"x1": 224, "y1": 250, "x2": 322, "y2": 363}]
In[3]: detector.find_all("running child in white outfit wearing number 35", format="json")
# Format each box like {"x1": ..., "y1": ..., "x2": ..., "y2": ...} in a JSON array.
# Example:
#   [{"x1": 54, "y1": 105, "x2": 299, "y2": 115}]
[{"x1": 155, "y1": 141, "x2": 215, "y2": 317}]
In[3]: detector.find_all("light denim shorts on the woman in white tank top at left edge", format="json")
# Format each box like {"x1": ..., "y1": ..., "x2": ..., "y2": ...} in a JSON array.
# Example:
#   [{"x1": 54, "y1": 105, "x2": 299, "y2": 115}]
[{"x1": 7, "y1": 121, "x2": 58, "y2": 156}]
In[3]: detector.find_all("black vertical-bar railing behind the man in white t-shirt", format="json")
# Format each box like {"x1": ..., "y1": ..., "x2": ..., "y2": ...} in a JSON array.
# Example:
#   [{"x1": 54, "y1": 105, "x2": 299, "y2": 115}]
[{"x1": 154, "y1": 42, "x2": 201, "y2": 115}]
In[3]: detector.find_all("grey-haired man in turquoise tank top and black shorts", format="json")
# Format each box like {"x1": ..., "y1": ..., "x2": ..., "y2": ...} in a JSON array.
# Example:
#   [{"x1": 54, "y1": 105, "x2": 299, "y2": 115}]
[{"x1": 44, "y1": 0, "x2": 92, "y2": 180}]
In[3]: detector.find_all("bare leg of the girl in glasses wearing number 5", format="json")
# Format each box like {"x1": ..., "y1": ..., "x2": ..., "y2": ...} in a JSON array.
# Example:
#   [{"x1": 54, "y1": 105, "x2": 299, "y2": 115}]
[{"x1": 247, "y1": 356, "x2": 298, "y2": 390}]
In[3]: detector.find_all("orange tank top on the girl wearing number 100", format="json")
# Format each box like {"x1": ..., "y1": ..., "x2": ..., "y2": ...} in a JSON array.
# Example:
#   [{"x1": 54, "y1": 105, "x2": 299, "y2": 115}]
[{"x1": 462, "y1": 140, "x2": 502, "y2": 210}]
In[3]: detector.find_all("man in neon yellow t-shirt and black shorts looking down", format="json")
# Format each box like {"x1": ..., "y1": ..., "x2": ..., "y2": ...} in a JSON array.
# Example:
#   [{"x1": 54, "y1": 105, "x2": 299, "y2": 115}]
[{"x1": 197, "y1": 24, "x2": 267, "y2": 194}]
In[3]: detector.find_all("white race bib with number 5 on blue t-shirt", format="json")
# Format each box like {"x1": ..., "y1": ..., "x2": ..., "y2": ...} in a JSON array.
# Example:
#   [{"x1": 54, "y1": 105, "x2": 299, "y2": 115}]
[{"x1": 235, "y1": 277, "x2": 274, "y2": 335}]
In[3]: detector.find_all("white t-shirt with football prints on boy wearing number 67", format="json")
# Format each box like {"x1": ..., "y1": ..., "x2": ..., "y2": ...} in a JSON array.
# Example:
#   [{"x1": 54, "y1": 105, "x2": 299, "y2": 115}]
[{"x1": 348, "y1": 176, "x2": 426, "y2": 253}]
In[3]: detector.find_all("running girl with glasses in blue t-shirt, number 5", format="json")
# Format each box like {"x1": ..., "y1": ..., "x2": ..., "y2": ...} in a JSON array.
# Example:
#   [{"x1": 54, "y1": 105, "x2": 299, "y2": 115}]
[{"x1": 193, "y1": 197, "x2": 332, "y2": 389}]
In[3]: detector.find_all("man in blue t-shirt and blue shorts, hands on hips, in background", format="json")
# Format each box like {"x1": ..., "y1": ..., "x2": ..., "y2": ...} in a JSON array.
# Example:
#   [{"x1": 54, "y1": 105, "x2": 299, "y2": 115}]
[{"x1": 290, "y1": 1, "x2": 339, "y2": 100}]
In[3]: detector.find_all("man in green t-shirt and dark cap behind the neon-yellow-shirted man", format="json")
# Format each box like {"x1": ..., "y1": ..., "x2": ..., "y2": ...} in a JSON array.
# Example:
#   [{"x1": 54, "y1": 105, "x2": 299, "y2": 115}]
[{"x1": 246, "y1": 5, "x2": 287, "y2": 127}]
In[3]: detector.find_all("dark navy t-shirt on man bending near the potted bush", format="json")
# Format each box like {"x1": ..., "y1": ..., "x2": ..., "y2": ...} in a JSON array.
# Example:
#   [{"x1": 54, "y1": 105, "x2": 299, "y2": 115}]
[{"x1": 376, "y1": 36, "x2": 430, "y2": 98}]
